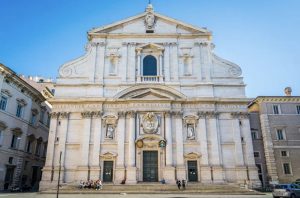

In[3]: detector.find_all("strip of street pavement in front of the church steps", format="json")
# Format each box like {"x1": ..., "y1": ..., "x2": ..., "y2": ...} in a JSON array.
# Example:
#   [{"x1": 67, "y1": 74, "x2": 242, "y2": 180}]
[{"x1": 0, "y1": 193, "x2": 272, "y2": 198}]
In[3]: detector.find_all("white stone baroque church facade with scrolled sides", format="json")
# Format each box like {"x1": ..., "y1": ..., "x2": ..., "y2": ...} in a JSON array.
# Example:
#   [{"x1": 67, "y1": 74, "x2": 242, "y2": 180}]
[{"x1": 40, "y1": 4, "x2": 260, "y2": 189}]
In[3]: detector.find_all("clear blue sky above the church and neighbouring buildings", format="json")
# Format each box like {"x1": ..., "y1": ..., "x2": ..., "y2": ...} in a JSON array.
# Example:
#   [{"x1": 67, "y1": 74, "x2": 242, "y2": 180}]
[{"x1": 0, "y1": 0, "x2": 300, "y2": 97}]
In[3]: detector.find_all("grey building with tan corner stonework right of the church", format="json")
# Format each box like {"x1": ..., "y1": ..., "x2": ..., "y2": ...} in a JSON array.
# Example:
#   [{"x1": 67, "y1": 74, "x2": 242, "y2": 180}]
[{"x1": 249, "y1": 87, "x2": 300, "y2": 185}]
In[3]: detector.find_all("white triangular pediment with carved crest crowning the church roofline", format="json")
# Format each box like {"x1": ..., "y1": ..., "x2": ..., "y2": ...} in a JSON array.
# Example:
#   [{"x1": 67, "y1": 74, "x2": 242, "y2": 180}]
[{"x1": 88, "y1": 5, "x2": 211, "y2": 36}]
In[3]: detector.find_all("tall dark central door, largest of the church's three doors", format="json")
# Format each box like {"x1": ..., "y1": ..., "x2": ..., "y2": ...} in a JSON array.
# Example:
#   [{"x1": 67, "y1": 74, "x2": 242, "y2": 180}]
[{"x1": 143, "y1": 151, "x2": 158, "y2": 182}]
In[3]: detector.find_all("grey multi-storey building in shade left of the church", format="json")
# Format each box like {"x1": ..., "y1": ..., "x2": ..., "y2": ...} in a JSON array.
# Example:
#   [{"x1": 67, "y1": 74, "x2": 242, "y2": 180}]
[{"x1": 0, "y1": 64, "x2": 52, "y2": 190}]
